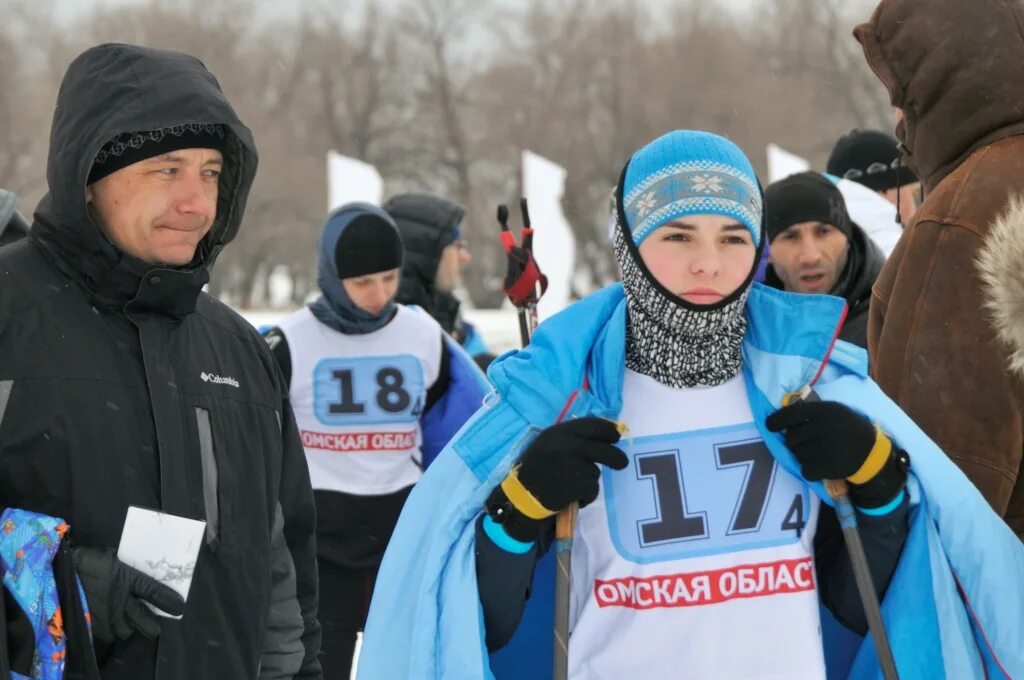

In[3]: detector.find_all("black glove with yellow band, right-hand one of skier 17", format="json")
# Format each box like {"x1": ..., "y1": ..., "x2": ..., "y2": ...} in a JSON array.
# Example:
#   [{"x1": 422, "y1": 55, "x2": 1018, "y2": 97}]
[{"x1": 765, "y1": 401, "x2": 906, "y2": 508}]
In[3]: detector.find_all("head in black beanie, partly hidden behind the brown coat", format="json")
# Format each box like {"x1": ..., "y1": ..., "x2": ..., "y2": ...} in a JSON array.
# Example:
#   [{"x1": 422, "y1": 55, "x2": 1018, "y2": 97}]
[{"x1": 825, "y1": 130, "x2": 921, "y2": 225}]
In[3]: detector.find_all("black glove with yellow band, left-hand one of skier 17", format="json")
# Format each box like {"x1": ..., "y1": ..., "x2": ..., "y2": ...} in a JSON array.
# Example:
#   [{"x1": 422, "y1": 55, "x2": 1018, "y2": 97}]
[{"x1": 487, "y1": 418, "x2": 629, "y2": 542}]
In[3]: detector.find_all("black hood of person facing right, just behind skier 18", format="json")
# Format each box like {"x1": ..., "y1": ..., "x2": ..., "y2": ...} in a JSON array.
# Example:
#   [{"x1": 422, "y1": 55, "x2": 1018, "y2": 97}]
[{"x1": 384, "y1": 194, "x2": 466, "y2": 323}]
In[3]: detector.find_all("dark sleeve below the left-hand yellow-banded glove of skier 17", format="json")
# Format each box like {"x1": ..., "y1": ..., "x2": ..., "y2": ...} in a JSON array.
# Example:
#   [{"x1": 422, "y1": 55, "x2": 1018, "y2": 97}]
[{"x1": 476, "y1": 514, "x2": 555, "y2": 652}]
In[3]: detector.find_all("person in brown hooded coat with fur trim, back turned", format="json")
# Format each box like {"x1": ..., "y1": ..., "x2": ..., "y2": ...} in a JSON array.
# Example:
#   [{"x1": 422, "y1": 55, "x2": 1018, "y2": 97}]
[{"x1": 854, "y1": 0, "x2": 1024, "y2": 538}]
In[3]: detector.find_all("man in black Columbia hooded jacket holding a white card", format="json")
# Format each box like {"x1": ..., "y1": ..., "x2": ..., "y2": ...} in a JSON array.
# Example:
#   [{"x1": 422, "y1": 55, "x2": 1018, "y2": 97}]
[{"x1": 0, "y1": 45, "x2": 321, "y2": 680}]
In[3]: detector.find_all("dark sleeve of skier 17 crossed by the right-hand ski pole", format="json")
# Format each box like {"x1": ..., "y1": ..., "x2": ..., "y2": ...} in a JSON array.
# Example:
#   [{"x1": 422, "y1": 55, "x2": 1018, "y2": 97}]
[{"x1": 814, "y1": 498, "x2": 909, "y2": 635}]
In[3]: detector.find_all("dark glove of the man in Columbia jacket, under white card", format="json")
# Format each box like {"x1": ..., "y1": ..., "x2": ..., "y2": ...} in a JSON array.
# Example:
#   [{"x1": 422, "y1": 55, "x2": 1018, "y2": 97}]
[{"x1": 74, "y1": 547, "x2": 185, "y2": 644}]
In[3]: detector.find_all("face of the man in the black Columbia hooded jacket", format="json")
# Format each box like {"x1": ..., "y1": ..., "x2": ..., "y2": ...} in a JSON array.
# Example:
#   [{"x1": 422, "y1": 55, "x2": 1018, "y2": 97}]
[{"x1": 85, "y1": 148, "x2": 223, "y2": 266}]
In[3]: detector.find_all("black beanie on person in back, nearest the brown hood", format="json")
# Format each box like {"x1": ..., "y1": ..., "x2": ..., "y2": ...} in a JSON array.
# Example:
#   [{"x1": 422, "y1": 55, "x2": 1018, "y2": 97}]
[{"x1": 825, "y1": 130, "x2": 918, "y2": 192}]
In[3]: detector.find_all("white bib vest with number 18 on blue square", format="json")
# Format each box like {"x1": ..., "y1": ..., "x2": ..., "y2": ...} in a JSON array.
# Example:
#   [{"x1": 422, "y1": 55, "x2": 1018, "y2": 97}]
[{"x1": 280, "y1": 305, "x2": 441, "y2": 496}]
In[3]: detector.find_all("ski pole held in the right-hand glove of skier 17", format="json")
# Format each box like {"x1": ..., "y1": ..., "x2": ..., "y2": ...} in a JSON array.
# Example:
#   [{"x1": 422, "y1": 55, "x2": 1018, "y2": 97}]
[{"x1": 782, "y1": 385, "x2": 899, "y2": 680}]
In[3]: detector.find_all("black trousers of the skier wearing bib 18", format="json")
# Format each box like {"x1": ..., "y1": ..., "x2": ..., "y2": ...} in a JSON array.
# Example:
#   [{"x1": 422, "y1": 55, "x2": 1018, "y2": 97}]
[{"x1": 317, "y1": 560, "x2": 378, "y2": 680}]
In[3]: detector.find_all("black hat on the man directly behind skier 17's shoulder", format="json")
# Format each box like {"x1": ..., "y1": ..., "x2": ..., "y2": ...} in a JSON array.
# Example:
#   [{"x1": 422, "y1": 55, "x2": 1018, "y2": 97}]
[{"x1": 765, "y1": 171, "x2": 853, "y2": 243}]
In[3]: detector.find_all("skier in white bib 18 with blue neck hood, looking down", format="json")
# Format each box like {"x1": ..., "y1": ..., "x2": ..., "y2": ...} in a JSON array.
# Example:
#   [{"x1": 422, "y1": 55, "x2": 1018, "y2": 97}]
[{"x1": 266, "y1": 203, "x2": 487, "y2": 679}]
